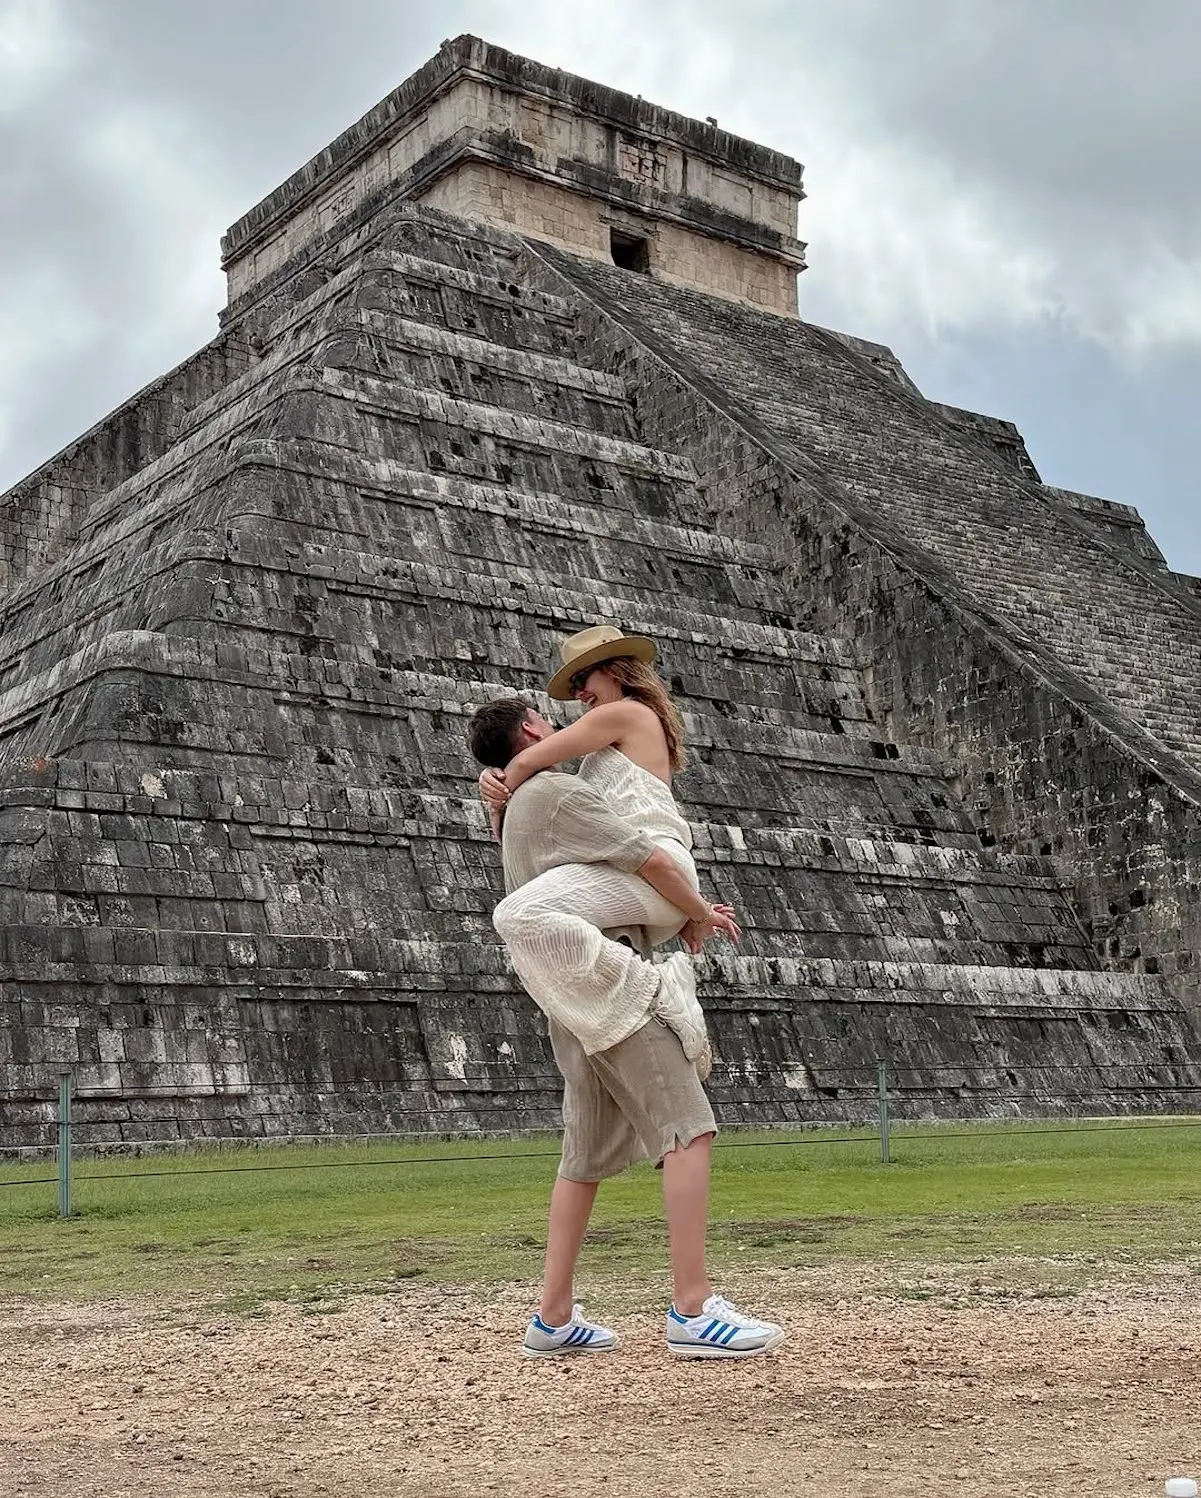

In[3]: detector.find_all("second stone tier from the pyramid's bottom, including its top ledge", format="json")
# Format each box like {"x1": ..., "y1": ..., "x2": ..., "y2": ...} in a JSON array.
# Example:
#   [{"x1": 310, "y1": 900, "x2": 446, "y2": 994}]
[{"x1": 0, "y1": 749, "x2": 1096, "y2": 968}]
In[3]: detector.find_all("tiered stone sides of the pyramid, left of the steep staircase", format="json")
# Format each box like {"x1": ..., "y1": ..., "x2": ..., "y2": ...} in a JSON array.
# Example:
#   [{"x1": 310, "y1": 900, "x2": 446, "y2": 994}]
[{"x1": 0, "y1": 208, "x2": 1201, "y2": 1144}]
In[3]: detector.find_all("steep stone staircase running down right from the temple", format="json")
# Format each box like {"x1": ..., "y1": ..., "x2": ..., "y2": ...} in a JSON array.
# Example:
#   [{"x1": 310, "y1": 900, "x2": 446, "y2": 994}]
[{"x1": 539, "y1": 247, "x2": 1201, "y2": 768}]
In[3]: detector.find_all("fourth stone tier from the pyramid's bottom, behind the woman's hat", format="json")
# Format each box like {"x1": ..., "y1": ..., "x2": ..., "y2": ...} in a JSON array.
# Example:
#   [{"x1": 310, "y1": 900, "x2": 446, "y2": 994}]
[{"x1": 0, "y1": 551, "x2": 856, "y2": 713}]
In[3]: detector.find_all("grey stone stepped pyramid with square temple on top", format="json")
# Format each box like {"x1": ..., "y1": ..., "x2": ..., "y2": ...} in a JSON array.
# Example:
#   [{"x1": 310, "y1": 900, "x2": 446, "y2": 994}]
[{"x1": 0, "y1": 36, "x2": 1201, "y2": 1149}]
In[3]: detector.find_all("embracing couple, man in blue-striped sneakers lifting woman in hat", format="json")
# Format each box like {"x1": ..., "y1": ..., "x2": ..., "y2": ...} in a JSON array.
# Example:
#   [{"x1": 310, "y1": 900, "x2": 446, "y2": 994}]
[{"x1": 469, "y1": 625, "x2": 785, "y2": 1357}]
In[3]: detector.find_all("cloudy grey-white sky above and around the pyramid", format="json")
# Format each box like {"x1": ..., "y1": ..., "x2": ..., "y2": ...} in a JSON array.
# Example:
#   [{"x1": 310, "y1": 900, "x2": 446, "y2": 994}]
[{"x1": 0, "y1": 0, "x2": 1201, "y2": 574}]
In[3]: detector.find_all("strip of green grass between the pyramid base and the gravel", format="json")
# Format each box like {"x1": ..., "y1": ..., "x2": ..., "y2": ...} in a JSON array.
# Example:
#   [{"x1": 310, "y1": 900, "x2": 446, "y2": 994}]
[{"x1": 0, "y1": 1119, "x2": 1201, "y2": 1309}]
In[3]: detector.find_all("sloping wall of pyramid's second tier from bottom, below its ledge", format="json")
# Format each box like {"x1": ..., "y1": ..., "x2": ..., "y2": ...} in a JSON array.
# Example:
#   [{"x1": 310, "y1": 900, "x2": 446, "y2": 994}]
[{"x1": 0, "y1": 812, "x2": 1096, "y2": 968}]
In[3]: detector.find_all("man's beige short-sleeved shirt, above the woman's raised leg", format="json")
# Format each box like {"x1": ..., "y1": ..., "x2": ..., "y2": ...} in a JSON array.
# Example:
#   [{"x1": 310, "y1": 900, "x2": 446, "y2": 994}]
[{"x1": 500, "y1": 770, "x2": 654, "y2": 894}]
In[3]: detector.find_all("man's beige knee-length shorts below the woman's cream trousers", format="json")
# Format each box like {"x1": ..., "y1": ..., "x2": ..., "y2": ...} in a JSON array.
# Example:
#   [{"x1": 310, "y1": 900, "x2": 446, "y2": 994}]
[{"x1": 550, "y1": 1019, "x2": 717, "y2": 1180}]
